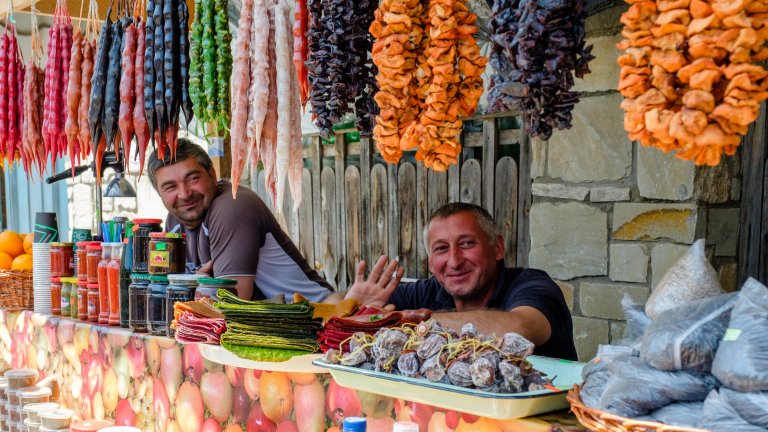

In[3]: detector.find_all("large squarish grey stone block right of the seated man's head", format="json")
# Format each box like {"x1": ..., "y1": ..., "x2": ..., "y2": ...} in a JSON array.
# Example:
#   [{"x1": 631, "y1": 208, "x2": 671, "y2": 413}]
[{"x1": 529, "y1": 202, "x2": 608, "y2": 280}]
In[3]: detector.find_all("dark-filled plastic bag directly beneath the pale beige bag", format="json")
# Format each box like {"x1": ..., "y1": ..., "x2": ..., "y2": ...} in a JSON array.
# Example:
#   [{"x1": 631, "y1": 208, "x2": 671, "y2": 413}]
[{"x1": 640, "y1": 293, "x2": 736, "y2": 373}]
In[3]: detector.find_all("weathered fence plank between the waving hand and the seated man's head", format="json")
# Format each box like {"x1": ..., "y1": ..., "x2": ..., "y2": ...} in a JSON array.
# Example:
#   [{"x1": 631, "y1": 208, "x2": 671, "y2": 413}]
[{"x1": 395, "y1": 162, "x2": 421, "y2": 277}]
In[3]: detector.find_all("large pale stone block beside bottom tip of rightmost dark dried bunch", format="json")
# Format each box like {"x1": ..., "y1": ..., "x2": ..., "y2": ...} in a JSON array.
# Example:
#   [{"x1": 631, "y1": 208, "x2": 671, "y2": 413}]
[{"x1": 547, "y1": 93, "x2": 632, "y2": 183}]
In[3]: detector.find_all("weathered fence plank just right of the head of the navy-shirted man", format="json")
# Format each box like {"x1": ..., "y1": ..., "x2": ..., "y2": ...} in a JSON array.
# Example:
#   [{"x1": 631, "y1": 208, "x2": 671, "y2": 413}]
[{"x1": 493, "y1": 156, "x2": 517, "y2": 264}]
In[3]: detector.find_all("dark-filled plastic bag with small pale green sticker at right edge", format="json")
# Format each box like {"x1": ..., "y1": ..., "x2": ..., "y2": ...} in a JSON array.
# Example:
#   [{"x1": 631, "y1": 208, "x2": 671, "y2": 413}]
[{"x1": 712, "y1": 278, "x2": 768, "y2": 392}]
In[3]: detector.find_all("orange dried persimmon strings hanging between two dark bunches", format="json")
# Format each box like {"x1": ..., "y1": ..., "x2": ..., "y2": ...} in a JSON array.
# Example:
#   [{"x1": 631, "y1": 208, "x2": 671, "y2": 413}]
[{"x1": 371, "y1": 0, "x2": 488, "y2": 171}]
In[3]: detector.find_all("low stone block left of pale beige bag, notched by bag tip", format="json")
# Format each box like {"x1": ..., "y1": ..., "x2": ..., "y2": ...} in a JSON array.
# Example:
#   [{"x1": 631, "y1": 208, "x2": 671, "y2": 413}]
[{"x1": 579, "y1": 282, "x2": 650, "y2": 320}]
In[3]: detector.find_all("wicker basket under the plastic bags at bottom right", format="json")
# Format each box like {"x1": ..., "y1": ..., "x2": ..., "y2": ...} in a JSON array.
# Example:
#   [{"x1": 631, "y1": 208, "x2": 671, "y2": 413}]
[{"x1": 567, "y1": 384, "x2": 708, "y2": 432}]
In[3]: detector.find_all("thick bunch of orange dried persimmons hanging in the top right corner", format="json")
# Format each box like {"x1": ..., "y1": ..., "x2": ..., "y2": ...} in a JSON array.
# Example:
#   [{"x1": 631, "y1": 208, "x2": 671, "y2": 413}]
[{"x1": 618, "y1": 0, "x2": 768, "y2": 166}]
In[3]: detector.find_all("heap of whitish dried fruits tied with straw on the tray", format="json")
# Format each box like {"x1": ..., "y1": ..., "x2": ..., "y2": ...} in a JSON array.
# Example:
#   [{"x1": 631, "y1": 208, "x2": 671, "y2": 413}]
[{"x1": 324, "y1": 320, "x2": 552, "y2": 393}]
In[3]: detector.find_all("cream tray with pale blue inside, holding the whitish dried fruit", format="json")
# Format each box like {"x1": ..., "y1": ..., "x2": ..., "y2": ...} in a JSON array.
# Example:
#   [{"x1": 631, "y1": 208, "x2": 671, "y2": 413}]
[{"x1": 314, "y1": 356, "x2": 584, "y2": 420}]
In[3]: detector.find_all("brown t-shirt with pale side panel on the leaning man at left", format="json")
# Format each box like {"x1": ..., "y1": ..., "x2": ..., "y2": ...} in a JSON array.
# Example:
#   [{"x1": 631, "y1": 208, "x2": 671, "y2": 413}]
[{"x1": 165, "y1": 181, "x2": 333, "y2": 301}]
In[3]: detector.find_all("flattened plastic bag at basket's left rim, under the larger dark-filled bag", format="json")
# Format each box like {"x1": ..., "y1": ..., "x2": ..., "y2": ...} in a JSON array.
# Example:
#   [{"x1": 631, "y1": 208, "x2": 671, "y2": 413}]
[{"x1": 600, "y1": 358, "x2": 717, "y2": 418}]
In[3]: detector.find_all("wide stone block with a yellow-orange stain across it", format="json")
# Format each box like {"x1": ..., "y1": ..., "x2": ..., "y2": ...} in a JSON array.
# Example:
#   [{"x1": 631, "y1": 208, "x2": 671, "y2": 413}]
[{"x1": 613, "y1": 203, "x2": 698, "y2": 243}]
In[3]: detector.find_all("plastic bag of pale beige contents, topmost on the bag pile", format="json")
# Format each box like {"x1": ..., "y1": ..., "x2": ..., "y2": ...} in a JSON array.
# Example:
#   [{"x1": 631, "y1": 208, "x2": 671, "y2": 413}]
[{"x1": 645, "y1": 239, "x2": 723, "y2": 320}]
